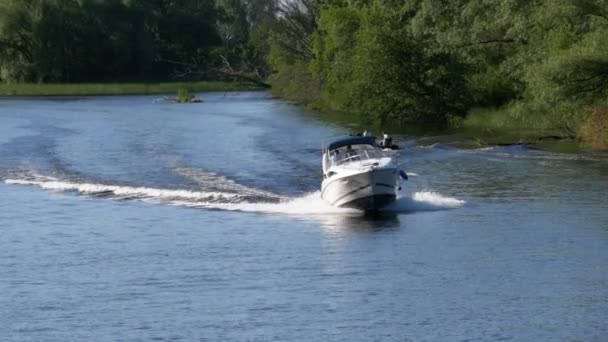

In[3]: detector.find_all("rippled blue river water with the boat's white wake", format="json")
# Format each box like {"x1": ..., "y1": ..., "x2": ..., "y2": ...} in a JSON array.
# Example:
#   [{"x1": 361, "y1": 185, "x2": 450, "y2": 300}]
[{"x1": 0, "y1": 92, "x2": 608, "y2": 341}]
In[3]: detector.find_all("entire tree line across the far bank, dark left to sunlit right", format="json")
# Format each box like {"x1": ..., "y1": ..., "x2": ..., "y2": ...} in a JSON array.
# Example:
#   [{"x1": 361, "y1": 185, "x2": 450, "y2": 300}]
[{"x1": 0, "y1": 0, "x2": 608, "y2": 145}]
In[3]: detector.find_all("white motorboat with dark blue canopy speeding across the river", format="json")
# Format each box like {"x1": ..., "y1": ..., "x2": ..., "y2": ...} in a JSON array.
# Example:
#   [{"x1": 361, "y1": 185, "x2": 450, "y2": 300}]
[{"x1": 321, "y1": 136, "x2": 404, "y2": 211}]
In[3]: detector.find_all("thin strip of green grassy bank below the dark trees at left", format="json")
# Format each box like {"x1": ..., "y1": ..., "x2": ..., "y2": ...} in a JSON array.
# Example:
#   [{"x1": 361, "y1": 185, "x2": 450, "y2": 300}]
[{"x1": 0, "y1": 82, "x2": 260, "y2": 96}]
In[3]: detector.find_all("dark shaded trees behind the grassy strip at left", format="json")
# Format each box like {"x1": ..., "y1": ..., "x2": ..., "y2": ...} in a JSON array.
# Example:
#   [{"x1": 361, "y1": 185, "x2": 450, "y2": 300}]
[{"x1": 0, "y1": 0, "x2": 267, "y2": 82}]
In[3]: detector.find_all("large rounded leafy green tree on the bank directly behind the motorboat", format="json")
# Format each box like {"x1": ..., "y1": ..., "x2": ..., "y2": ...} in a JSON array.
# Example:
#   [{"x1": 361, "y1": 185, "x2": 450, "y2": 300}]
[{"x1": 311, "y1": 3, "x2": 470, "y2": 124}]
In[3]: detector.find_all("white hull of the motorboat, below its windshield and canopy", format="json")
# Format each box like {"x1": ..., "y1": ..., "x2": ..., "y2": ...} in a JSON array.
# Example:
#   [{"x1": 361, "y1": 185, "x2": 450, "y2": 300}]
[{"x1": 321, "y1": 168, "x2": 399, "y2": 210}]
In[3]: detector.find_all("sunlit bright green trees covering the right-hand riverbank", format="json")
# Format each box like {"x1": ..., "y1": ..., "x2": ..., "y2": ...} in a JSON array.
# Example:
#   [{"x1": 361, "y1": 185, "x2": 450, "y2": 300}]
[{"x1": 269, "y1": 0, "x2": 608, "y2": 146}]
